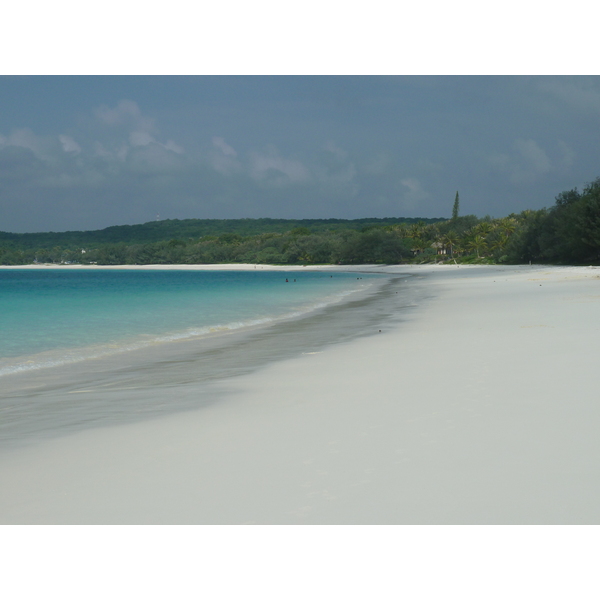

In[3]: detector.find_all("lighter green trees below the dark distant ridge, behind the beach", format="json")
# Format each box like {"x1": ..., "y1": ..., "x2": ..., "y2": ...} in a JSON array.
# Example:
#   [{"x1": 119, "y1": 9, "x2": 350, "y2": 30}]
[{"x1": 0, "y1": 215, "x2": 518, "y2": 265}]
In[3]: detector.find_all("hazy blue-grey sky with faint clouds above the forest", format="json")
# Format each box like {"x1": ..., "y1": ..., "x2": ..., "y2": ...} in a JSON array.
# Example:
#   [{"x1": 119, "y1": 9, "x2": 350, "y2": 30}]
[{"x1": 0, "y1": 75, "x2": 600, "y2": 232}]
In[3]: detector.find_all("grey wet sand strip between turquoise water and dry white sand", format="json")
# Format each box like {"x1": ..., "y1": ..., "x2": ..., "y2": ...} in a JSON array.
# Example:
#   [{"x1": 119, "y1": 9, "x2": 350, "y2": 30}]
[{"x1": 0, "y1": 272, "x2": 425, "y2": 447}]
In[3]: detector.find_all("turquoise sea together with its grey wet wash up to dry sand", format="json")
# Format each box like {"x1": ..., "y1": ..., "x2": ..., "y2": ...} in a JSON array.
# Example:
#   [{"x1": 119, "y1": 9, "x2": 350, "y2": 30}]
[{"x1": 0, "y1": 267, "x2": 411, "y2": 445}]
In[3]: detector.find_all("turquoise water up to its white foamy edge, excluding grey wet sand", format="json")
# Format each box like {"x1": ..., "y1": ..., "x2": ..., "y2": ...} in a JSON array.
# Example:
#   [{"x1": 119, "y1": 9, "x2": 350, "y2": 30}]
[{"x1": 0, "y1": 268, "x2": 377, "y2": 376}]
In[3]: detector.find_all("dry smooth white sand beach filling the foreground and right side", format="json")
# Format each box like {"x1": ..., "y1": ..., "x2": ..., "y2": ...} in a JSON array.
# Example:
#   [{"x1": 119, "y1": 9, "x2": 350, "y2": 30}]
[{"x1": 0, "y1": 265, "x2": 600, "y2": 524}]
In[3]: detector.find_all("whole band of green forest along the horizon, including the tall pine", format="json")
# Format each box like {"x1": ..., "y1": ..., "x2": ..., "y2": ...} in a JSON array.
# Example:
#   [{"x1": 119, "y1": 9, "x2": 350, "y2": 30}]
[{"x1": 0, "y1": 177, "x2": 600, "y2": 265}]
